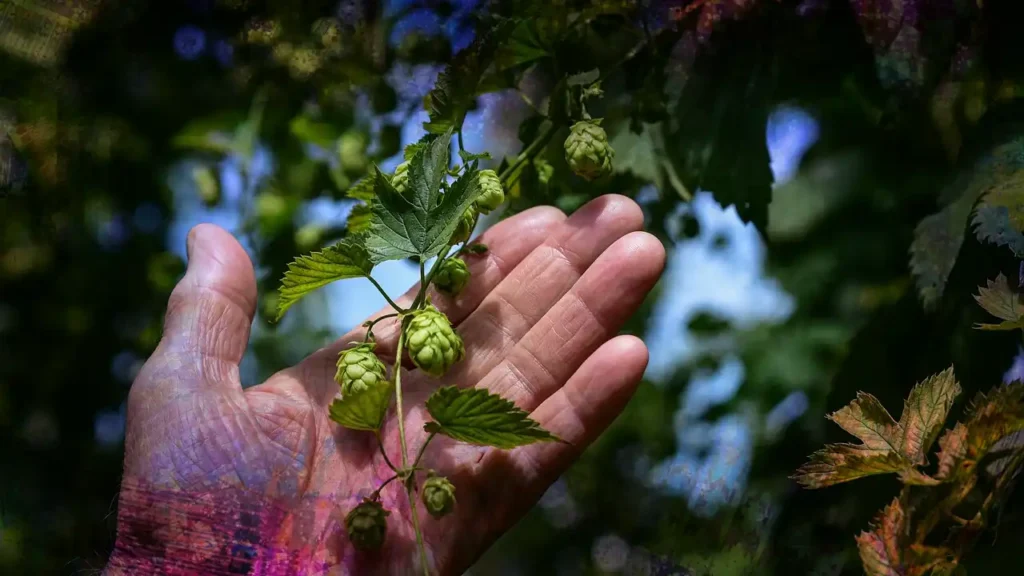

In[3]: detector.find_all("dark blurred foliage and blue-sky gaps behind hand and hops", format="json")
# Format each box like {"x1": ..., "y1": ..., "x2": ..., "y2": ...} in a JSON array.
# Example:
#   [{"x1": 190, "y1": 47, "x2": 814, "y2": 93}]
[{"x1": 6, "y1": 0, "x2": 1024, "y2": 576}]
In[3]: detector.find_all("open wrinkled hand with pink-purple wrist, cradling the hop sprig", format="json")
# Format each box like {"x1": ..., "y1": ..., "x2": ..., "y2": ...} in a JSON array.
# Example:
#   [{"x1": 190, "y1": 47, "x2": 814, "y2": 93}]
[{"x1": 104, "y1": 196, "x2": 665, "y2": 575}]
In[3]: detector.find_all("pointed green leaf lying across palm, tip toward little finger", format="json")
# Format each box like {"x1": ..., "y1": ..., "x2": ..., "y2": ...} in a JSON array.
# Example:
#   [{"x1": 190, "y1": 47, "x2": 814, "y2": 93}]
[{"x1": 424, "y1": 386, "x2": 559, "y2": 450}]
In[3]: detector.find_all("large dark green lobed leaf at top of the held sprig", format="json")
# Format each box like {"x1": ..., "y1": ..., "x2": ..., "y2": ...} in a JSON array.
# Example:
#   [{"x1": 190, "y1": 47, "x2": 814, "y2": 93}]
[{"x1": 366, "y1": 131, "x2": 480, "y2": 263}]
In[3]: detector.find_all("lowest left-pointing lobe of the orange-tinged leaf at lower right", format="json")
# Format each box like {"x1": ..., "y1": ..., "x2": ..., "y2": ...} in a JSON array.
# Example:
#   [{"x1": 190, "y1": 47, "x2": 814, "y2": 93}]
[{"x1": 791, "y1": 444, "x2": 910, "y2": 489}]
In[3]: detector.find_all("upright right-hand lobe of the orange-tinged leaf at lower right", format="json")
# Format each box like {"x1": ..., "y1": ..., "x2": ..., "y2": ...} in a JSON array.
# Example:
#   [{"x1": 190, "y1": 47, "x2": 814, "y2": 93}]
[{"x1": 899, "y1": 366, "x2": 961, "y2": 464}]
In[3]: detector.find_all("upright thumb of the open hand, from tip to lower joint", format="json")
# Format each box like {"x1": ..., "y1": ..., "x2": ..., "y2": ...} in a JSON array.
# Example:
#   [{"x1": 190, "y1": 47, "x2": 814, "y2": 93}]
[{"x1": 160, "y1": 223, "x2": 256, "y2": 381}]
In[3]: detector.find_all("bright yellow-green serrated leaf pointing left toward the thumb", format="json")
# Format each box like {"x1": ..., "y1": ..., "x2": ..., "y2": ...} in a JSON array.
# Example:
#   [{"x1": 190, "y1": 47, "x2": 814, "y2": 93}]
[{"x1": 276, "y1": 239, "x2": 373, "y2": 321}]
